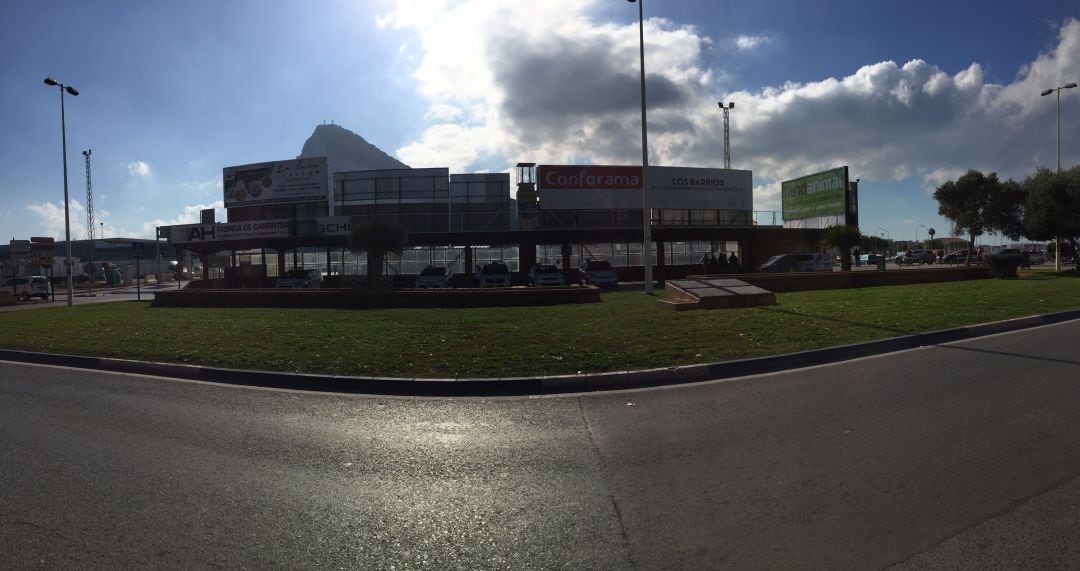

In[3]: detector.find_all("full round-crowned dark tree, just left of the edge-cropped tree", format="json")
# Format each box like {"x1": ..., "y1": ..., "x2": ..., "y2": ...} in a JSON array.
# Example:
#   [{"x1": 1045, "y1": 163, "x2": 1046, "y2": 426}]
[{"x1": 934, "y1": 171, "x2": 1023, "y2": 264}]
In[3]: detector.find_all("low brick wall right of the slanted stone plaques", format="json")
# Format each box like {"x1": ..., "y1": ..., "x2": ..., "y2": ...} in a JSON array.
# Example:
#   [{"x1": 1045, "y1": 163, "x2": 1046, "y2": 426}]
[{"x1": 687, "y1": 266, "x2": 990, "y2": 294}]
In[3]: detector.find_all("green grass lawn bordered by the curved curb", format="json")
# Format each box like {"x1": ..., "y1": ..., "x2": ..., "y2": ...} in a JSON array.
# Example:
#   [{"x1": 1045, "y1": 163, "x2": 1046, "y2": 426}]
[{"x1": 0, "y1": 271, "x2": 1080, "y2": 378}]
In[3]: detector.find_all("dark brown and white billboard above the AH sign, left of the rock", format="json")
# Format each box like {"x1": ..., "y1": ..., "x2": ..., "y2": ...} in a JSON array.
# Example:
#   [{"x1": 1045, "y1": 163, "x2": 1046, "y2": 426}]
[{"x1": 222, "y1": 157, "x2": 329, "y2": 208}]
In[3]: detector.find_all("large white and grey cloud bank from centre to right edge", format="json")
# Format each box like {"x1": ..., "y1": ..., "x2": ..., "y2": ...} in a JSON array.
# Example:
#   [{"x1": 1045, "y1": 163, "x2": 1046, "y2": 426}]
[{"x1": 380, "y1": 0, "x2": 1080, "y2": 209}]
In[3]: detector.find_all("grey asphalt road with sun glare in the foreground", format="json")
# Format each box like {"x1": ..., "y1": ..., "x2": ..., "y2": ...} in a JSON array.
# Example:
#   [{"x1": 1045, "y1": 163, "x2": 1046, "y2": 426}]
[{"x1": 0, "y1": 322, "x2": 1080, "y2": 570}]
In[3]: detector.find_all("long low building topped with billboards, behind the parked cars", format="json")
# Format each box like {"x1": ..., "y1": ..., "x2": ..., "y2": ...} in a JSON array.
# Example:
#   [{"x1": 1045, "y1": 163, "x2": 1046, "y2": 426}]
[{"x1": 162, "y1": 158, "x2": 818, "y2": 287}]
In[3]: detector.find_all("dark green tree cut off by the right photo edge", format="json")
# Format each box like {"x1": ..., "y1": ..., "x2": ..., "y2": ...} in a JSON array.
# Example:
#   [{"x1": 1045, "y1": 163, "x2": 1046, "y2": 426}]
[{"x1": 1023, "y1": 166, "x2": 1080, "y2": 269}]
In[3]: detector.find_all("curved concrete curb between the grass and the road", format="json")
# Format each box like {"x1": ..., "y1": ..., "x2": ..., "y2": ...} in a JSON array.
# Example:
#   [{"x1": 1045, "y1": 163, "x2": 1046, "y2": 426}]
[{"x1": 0, "y1": 310, "x2": 1080, "y2": 396}]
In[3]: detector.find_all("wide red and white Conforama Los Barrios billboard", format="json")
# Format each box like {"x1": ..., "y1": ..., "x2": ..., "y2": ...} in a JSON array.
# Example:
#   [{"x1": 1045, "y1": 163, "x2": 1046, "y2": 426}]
[{"x1": 537, "y1": 165, "x2": 754, "y2": 210}]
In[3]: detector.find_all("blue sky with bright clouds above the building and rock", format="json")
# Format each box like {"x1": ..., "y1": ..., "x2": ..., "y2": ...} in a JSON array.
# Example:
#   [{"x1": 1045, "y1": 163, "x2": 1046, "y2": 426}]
[{"x1": 0, "y1": 0, "x2": 1080, "y2": 245}]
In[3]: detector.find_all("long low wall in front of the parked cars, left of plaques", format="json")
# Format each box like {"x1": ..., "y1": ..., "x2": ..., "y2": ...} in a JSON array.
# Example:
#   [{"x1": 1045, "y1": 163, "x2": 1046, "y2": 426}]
[{"x1": 151, "y1": 286, "x2": 600, "y2": 309}]
